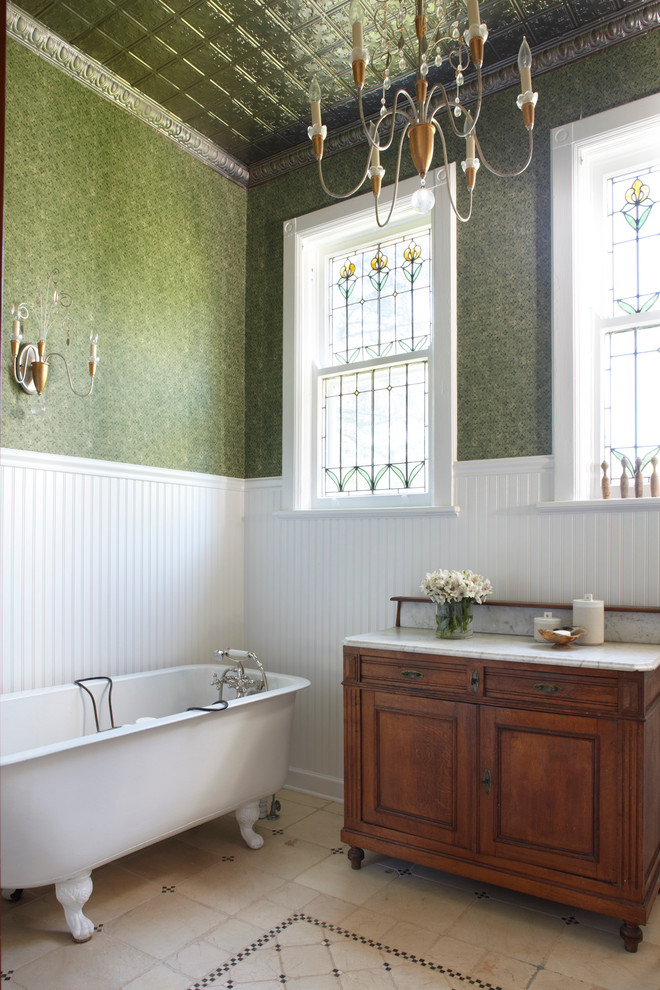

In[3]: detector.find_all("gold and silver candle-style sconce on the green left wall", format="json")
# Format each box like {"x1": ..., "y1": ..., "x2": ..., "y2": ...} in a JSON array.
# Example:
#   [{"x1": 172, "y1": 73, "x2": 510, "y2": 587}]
[{"x1": 10, "y1": 270, "x2": 99, "y2": 413}]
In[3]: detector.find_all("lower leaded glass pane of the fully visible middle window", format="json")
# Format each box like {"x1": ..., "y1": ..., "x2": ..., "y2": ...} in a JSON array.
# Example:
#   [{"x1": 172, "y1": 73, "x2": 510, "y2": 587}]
[{"x1": 321, "y1": 361, "x2": 428, "y2": 496}]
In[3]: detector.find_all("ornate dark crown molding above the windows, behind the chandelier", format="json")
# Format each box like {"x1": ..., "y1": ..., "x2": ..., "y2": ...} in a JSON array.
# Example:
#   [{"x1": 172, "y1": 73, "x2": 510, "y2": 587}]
[{"x1": 249, "y1": 0, "x2": 660, "y2": 188}]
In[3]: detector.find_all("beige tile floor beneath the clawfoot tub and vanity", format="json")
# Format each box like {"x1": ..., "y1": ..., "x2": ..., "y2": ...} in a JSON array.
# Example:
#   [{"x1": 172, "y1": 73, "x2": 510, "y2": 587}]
[{"x1": 0, "y1": 791, "x2": 660, "y2": 990}]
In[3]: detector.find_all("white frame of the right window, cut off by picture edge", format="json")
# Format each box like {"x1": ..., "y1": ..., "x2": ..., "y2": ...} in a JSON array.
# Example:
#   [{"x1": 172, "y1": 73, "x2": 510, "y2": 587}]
[{"x1": 551, "y1": 95, "x2": 660, "y2": 502}]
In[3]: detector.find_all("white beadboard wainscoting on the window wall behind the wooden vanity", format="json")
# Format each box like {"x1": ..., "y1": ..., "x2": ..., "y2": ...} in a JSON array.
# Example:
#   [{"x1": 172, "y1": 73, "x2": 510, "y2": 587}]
[{"x1": 244, "y1": 457, "x2": 660, "y2": 798}]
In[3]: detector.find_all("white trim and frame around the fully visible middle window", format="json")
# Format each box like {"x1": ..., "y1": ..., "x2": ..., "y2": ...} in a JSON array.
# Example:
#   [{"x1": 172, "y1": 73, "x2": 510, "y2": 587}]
[{"x1": 282, "y1": 165, "x2": 458, "y2": 515}]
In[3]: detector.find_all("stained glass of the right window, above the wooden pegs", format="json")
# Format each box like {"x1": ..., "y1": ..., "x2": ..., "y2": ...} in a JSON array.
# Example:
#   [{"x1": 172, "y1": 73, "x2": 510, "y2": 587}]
[{"x1": 603, "y1": 164, "x2": 660, "y2": 488}]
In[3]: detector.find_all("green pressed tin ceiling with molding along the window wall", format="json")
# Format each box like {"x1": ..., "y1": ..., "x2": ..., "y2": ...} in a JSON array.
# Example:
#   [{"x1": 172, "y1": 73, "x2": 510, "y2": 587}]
[{"x1": 8, "y1": 0, "x2": 660, "y2": 184}]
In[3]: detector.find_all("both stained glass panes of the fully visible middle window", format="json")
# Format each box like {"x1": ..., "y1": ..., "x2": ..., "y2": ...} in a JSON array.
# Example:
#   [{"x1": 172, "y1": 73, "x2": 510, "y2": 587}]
[{"x1": 319, "y1": 230, "x2": 432, "y2": 497}]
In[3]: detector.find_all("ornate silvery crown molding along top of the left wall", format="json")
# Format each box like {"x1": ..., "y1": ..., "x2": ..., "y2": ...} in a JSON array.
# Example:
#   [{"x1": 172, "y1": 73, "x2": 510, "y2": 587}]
[{"x1": 7, "y1": 3, "x2": 249, "y2": 188}]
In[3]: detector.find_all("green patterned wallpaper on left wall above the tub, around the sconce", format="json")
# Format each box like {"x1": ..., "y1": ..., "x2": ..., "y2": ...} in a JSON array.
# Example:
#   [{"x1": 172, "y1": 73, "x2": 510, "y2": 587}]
[{"x1": 2, "y1": 40, "x2": 247, "y2": 477}]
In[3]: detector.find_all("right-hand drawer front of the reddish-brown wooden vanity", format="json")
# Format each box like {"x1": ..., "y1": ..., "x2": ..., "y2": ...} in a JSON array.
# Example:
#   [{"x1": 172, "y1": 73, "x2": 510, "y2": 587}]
[{"x1": 484, "y1": 666, "x2": 619, "y2": 712}]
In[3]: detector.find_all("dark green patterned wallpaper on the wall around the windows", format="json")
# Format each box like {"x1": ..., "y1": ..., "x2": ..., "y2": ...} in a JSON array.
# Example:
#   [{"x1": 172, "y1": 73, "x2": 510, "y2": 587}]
[{"x1": 246, "y1": 31, "x2": 660, "y2": 477}]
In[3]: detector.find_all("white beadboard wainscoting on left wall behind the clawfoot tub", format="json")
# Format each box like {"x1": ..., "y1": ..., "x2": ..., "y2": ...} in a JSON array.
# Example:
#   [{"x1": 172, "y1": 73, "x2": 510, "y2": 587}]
[{"x1": 0, "y1": 449, "x2": 244, "y2": 692}]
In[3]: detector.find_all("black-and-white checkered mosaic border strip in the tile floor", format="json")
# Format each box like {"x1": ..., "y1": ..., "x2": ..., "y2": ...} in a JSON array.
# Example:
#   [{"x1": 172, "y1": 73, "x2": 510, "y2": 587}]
[{"x1": 188, "y1": 912, "x2": 502, "y2": 990}]
